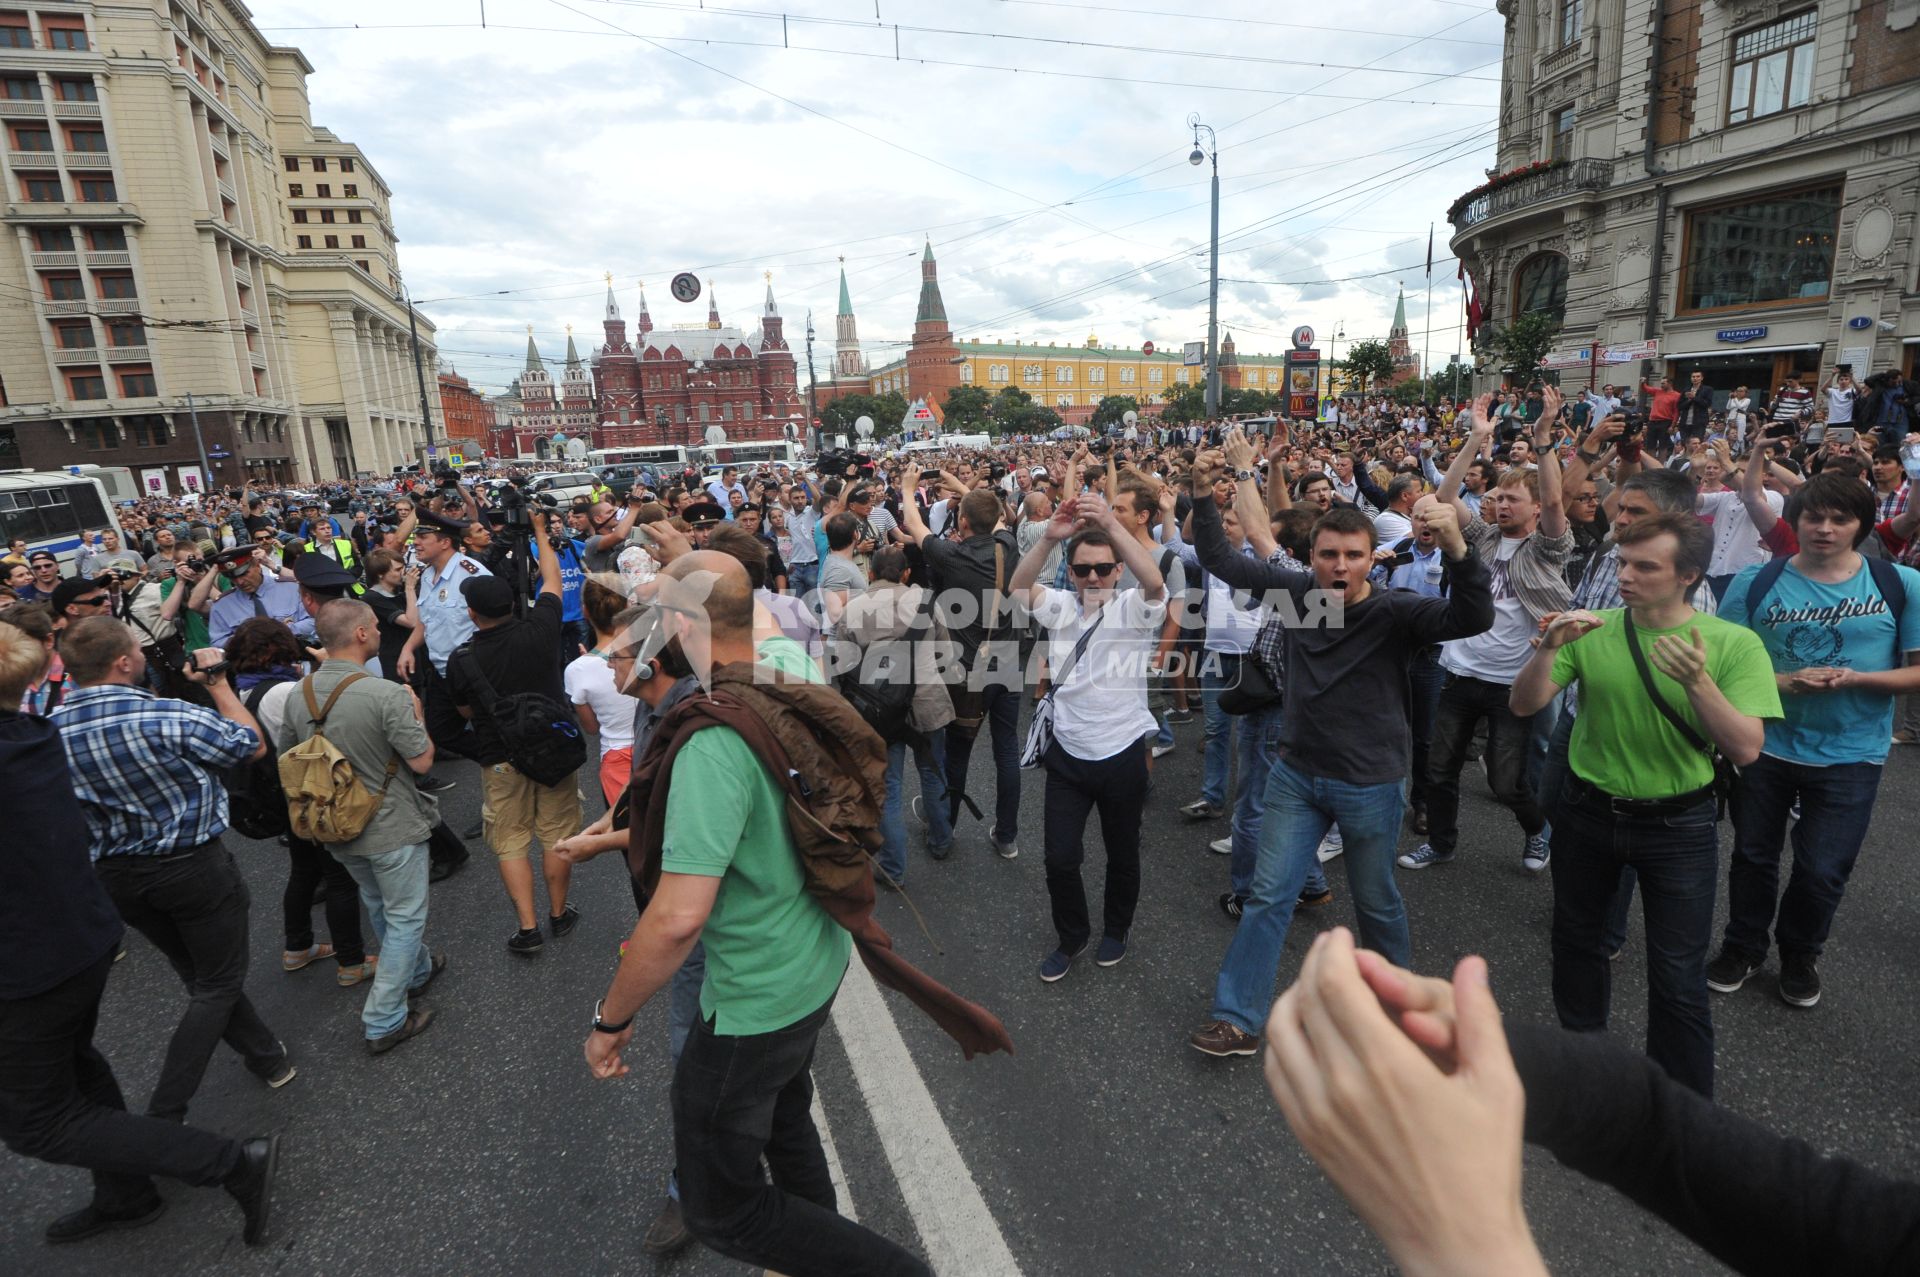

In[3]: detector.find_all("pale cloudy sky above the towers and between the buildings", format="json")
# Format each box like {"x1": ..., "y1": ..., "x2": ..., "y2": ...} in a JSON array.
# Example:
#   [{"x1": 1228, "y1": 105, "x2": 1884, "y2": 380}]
[{"x1": 253, "y1": 0, "x2": 1501, "y2": 388}]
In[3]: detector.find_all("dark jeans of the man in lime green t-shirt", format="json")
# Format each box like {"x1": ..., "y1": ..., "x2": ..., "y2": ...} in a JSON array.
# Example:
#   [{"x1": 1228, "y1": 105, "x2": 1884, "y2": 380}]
[{"x1": 1551, "y1": 778, "x2": 1720, "y2": 1098}]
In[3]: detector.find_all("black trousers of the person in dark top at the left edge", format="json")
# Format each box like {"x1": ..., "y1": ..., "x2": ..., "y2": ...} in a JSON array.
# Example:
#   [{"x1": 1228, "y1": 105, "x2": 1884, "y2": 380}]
[{"x1": 0, "y1": 949, "x2": 240, "y2": 1214}]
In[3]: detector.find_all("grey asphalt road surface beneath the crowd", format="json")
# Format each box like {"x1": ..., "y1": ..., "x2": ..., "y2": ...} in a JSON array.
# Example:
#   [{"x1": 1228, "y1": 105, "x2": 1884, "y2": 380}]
[{"x1": 0, "y1": 722, "x2": 1920, "y2": 1277}]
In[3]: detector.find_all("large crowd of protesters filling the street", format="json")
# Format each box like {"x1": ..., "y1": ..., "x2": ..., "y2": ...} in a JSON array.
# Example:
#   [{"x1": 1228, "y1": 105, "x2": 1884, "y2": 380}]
[{"x1": 0, "y1": 351, "x2": 1920, "y2": 1273}]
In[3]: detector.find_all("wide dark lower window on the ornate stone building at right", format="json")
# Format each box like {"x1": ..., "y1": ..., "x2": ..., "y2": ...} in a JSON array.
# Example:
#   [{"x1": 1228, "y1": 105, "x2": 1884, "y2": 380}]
[{"x1": 1680, "y1": 186, "x2": 1839, "y2": 311}]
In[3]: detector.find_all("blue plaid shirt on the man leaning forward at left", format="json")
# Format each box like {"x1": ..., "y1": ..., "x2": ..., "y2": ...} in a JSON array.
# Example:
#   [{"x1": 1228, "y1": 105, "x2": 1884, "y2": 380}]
[{"x1": 52, "y1": 684, "x2": 259, "y2": 860}]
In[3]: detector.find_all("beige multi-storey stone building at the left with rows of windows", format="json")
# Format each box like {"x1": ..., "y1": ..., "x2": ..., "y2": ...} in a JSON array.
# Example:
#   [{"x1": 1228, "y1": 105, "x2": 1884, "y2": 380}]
[{"x1": 0, "y1": 0, "x2": 434, "y2": 494}]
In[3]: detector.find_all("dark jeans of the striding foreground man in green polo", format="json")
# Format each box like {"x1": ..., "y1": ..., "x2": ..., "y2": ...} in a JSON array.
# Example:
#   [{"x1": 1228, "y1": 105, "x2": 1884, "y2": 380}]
[{"x1": 672, "y1": 999, "x2": 931, "y2": 1277}]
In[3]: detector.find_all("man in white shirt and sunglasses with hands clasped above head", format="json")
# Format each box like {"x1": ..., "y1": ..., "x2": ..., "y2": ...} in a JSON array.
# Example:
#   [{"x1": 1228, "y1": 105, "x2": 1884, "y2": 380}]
[{"x1": 1008, "y1": 485, "x2": 1167, "y2": 983}]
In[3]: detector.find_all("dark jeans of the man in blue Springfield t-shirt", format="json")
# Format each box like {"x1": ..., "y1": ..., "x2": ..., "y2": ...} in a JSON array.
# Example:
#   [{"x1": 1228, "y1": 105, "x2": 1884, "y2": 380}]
[{"x1": 1726, "y1": 755, "x2": 1882, "y2": 962}]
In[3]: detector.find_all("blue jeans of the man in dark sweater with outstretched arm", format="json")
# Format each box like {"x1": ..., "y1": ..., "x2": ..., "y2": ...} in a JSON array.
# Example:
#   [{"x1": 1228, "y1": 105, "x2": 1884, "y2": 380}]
[{"x1": 1213, "y1": 759, "x2": 1413, "y2": 1033}]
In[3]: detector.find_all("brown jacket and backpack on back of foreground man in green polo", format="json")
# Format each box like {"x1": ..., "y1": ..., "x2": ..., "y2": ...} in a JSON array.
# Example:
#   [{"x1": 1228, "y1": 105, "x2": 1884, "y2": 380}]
[{"x1": 626, "y1": 663, "x2": 1014, "y2": 1060}]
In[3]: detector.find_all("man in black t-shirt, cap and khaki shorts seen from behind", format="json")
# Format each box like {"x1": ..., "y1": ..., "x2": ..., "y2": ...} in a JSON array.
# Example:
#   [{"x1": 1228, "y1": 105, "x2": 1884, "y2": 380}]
[{"x1": 447, "y1": 511, "x2": 580, "y2": 958}]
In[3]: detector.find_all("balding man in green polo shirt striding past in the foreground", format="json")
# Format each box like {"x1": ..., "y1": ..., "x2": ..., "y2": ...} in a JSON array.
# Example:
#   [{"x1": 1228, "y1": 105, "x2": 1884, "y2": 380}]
[{"x1": 586, "y1": 551, "x2": 929, "y2": 1273}]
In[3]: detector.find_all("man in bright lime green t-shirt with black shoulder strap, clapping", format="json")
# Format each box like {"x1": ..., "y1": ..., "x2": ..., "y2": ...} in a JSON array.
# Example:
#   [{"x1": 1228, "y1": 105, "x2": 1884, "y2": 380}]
[{"x1": 1513, "y1": 513, "x2": 1780, "y2": 1098}]
